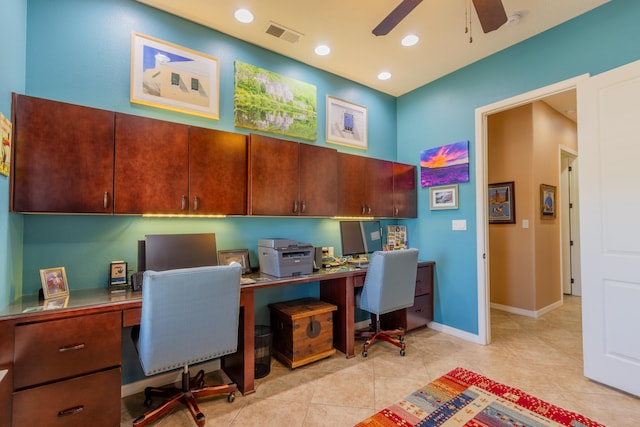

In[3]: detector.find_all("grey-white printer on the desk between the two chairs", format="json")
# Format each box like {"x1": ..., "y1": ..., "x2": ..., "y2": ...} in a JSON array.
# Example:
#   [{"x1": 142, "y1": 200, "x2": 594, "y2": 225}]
[{"x1": 258, "y1": 239, "x2": 314, "y2": 277}]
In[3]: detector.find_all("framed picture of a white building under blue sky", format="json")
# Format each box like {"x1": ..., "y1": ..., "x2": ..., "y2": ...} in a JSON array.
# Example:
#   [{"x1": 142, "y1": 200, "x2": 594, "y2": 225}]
[{"x1": 131, "y1": 32, "x2": 220, "y2": 119}]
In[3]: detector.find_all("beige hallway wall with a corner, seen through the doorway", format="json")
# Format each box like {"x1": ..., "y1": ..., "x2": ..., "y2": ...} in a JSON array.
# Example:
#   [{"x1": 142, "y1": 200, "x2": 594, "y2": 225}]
[{"x1": 488, "y1": 101, "x2": 577, "y2": 312}]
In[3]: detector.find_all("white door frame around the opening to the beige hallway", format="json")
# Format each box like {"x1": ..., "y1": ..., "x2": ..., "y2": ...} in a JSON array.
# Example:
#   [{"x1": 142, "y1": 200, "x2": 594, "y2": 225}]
[{"x1": 475, "y1": 74, "x2": 589, "y2": 344}]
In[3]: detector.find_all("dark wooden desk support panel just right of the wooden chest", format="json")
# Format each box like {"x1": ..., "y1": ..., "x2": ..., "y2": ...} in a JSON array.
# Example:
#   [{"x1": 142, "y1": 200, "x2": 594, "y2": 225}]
[{"x1": 320, "y1": 277, "x2": 355, "y2": 359}]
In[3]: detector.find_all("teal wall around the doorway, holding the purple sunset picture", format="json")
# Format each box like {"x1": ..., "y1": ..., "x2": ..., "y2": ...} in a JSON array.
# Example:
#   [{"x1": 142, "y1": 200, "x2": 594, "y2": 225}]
[{"x1": 398, "y1": 0, "x2": 640, "y2": 334}]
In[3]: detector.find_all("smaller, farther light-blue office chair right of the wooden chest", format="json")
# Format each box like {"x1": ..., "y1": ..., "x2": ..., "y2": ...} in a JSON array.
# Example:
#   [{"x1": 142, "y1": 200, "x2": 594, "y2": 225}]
[{"x1": 357, "y1": 249, "x2": 418, "y2": 357}]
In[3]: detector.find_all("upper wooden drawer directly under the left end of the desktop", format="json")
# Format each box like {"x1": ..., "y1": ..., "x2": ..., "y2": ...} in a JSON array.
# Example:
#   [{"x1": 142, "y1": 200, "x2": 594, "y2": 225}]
[{"x1": 13, "y1": 311, "x2": 122, "y2": 390}]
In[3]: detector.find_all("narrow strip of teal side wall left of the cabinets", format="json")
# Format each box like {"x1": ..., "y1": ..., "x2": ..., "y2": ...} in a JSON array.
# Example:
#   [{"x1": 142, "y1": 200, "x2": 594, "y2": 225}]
[{"x1": 0, "y1": 0, "x2": 27, "y2": 307}]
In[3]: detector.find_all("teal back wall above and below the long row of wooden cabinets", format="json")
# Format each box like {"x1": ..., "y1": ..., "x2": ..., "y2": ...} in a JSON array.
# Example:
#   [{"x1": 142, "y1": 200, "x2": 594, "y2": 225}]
[{"x1": 22, "y1": 0, "x2": 398, "y2": 304}]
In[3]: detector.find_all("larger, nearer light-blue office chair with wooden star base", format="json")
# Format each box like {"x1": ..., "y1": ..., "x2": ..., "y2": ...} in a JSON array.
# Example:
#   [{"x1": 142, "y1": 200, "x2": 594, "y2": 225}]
[{"x1": 133, "y1": 263, "x2": 242, "y2": 426}]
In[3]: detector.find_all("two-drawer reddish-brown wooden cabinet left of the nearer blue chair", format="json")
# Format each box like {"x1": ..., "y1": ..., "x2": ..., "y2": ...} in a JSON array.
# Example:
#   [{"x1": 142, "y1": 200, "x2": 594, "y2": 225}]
[{"x1": 12, "y1": 311, "x2": 122, "y2": 426}]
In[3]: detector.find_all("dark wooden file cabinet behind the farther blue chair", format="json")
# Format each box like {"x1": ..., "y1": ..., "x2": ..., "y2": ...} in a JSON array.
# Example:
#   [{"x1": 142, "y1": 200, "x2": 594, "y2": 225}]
[{"x1": 380, "y1": 263, "x2": 434, "y2": 331}]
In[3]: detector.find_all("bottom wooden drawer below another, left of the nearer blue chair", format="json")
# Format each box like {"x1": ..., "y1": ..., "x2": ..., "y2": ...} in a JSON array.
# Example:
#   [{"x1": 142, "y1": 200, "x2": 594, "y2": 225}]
[{"x1": 13, "y1": 368, "x2": 121, "y2": 427}]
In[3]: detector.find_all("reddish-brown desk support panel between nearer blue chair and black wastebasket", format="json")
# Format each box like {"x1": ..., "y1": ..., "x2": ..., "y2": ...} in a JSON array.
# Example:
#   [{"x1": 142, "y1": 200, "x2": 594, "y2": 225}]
[{"x1": 222, "y1": 290, "x2": 256, "y2": 396}]
